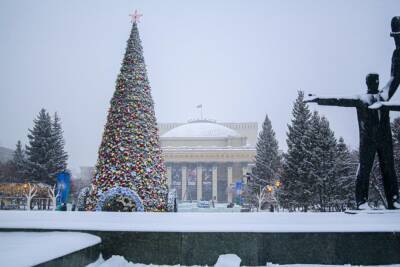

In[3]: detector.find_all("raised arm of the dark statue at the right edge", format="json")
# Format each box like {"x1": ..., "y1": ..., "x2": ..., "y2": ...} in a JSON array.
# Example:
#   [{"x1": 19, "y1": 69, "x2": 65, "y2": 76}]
[{"x1": 380, "y1": 17, "x2": 400, "y2": 101}]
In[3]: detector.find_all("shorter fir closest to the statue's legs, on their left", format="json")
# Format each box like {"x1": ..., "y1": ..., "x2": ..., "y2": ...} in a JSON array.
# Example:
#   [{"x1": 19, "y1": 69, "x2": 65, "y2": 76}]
[{"x1": 333, "y1": 137, "x2": 358, "y2": 211}]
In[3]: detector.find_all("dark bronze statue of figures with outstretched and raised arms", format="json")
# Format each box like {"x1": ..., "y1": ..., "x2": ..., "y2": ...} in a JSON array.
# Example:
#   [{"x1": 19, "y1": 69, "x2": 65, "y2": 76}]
[{"x1": 306, "y1": 17, "x2": 400, "y2": 209}]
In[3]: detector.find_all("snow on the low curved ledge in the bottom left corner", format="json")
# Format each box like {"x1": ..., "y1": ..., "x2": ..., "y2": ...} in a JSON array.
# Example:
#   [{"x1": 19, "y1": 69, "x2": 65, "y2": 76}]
[{"x1": 0, "y1": 232, "x2": 101, "y2": 267}]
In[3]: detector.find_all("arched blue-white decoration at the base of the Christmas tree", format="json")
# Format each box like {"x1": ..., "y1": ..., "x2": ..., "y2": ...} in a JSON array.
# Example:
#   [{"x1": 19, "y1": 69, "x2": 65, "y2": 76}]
[{"x1": 96, "y1": 187, "x2": 144, "y2": 211}]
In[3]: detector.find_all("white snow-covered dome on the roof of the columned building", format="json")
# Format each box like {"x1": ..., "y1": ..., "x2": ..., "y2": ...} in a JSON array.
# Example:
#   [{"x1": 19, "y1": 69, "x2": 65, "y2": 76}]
[{"x1": 161, "y1": 120, "x2": 240, "y2": 138}]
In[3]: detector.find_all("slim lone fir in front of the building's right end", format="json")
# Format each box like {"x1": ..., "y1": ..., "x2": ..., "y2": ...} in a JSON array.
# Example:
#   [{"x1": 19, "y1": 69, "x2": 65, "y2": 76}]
[{"x1": 253, "y1": 115, "x2": 281, "y2": 184}]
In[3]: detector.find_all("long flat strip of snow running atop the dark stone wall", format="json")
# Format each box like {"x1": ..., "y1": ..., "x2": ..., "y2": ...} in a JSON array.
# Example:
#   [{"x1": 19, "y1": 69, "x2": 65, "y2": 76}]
[{"x1": 0, "y1": 211, "x2": 400, "y2": 232}]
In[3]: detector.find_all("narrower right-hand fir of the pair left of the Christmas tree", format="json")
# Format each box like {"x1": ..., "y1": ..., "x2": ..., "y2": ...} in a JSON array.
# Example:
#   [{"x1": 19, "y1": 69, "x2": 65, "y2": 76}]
[{"x1": 52, "y1": 113, "x2": 68, "y2": 173}]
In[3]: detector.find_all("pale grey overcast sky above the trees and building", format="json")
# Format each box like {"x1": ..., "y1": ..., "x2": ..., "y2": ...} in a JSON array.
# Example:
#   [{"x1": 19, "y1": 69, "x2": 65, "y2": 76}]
[{"x1": 0, "y1": 0, "x2": 400, "y2": 173}]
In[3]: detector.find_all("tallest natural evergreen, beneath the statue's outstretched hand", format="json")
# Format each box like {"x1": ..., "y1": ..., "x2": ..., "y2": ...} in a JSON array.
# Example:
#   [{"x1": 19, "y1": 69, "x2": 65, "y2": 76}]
[{"x1": 280, "y1": 91, "x2": 311, "y2": 210}]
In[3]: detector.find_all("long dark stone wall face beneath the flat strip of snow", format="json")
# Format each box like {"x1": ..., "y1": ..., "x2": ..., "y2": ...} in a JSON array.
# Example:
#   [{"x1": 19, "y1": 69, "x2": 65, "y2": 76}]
[{"x1": 89, "y1": 231, "x2": 400, "y2": 266}]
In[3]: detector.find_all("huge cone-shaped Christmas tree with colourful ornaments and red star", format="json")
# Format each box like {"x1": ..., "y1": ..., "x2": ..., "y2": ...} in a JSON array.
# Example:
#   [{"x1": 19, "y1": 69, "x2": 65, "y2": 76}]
[{"x1": 86, "y1": 12, "x2": 168, "y2": 211}]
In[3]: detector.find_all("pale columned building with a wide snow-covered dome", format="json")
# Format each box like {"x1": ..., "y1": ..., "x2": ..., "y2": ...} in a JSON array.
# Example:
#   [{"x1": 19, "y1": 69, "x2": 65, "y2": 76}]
[{"x1": 159, "y1": 120, "x2": 258, "y2": 202}]
